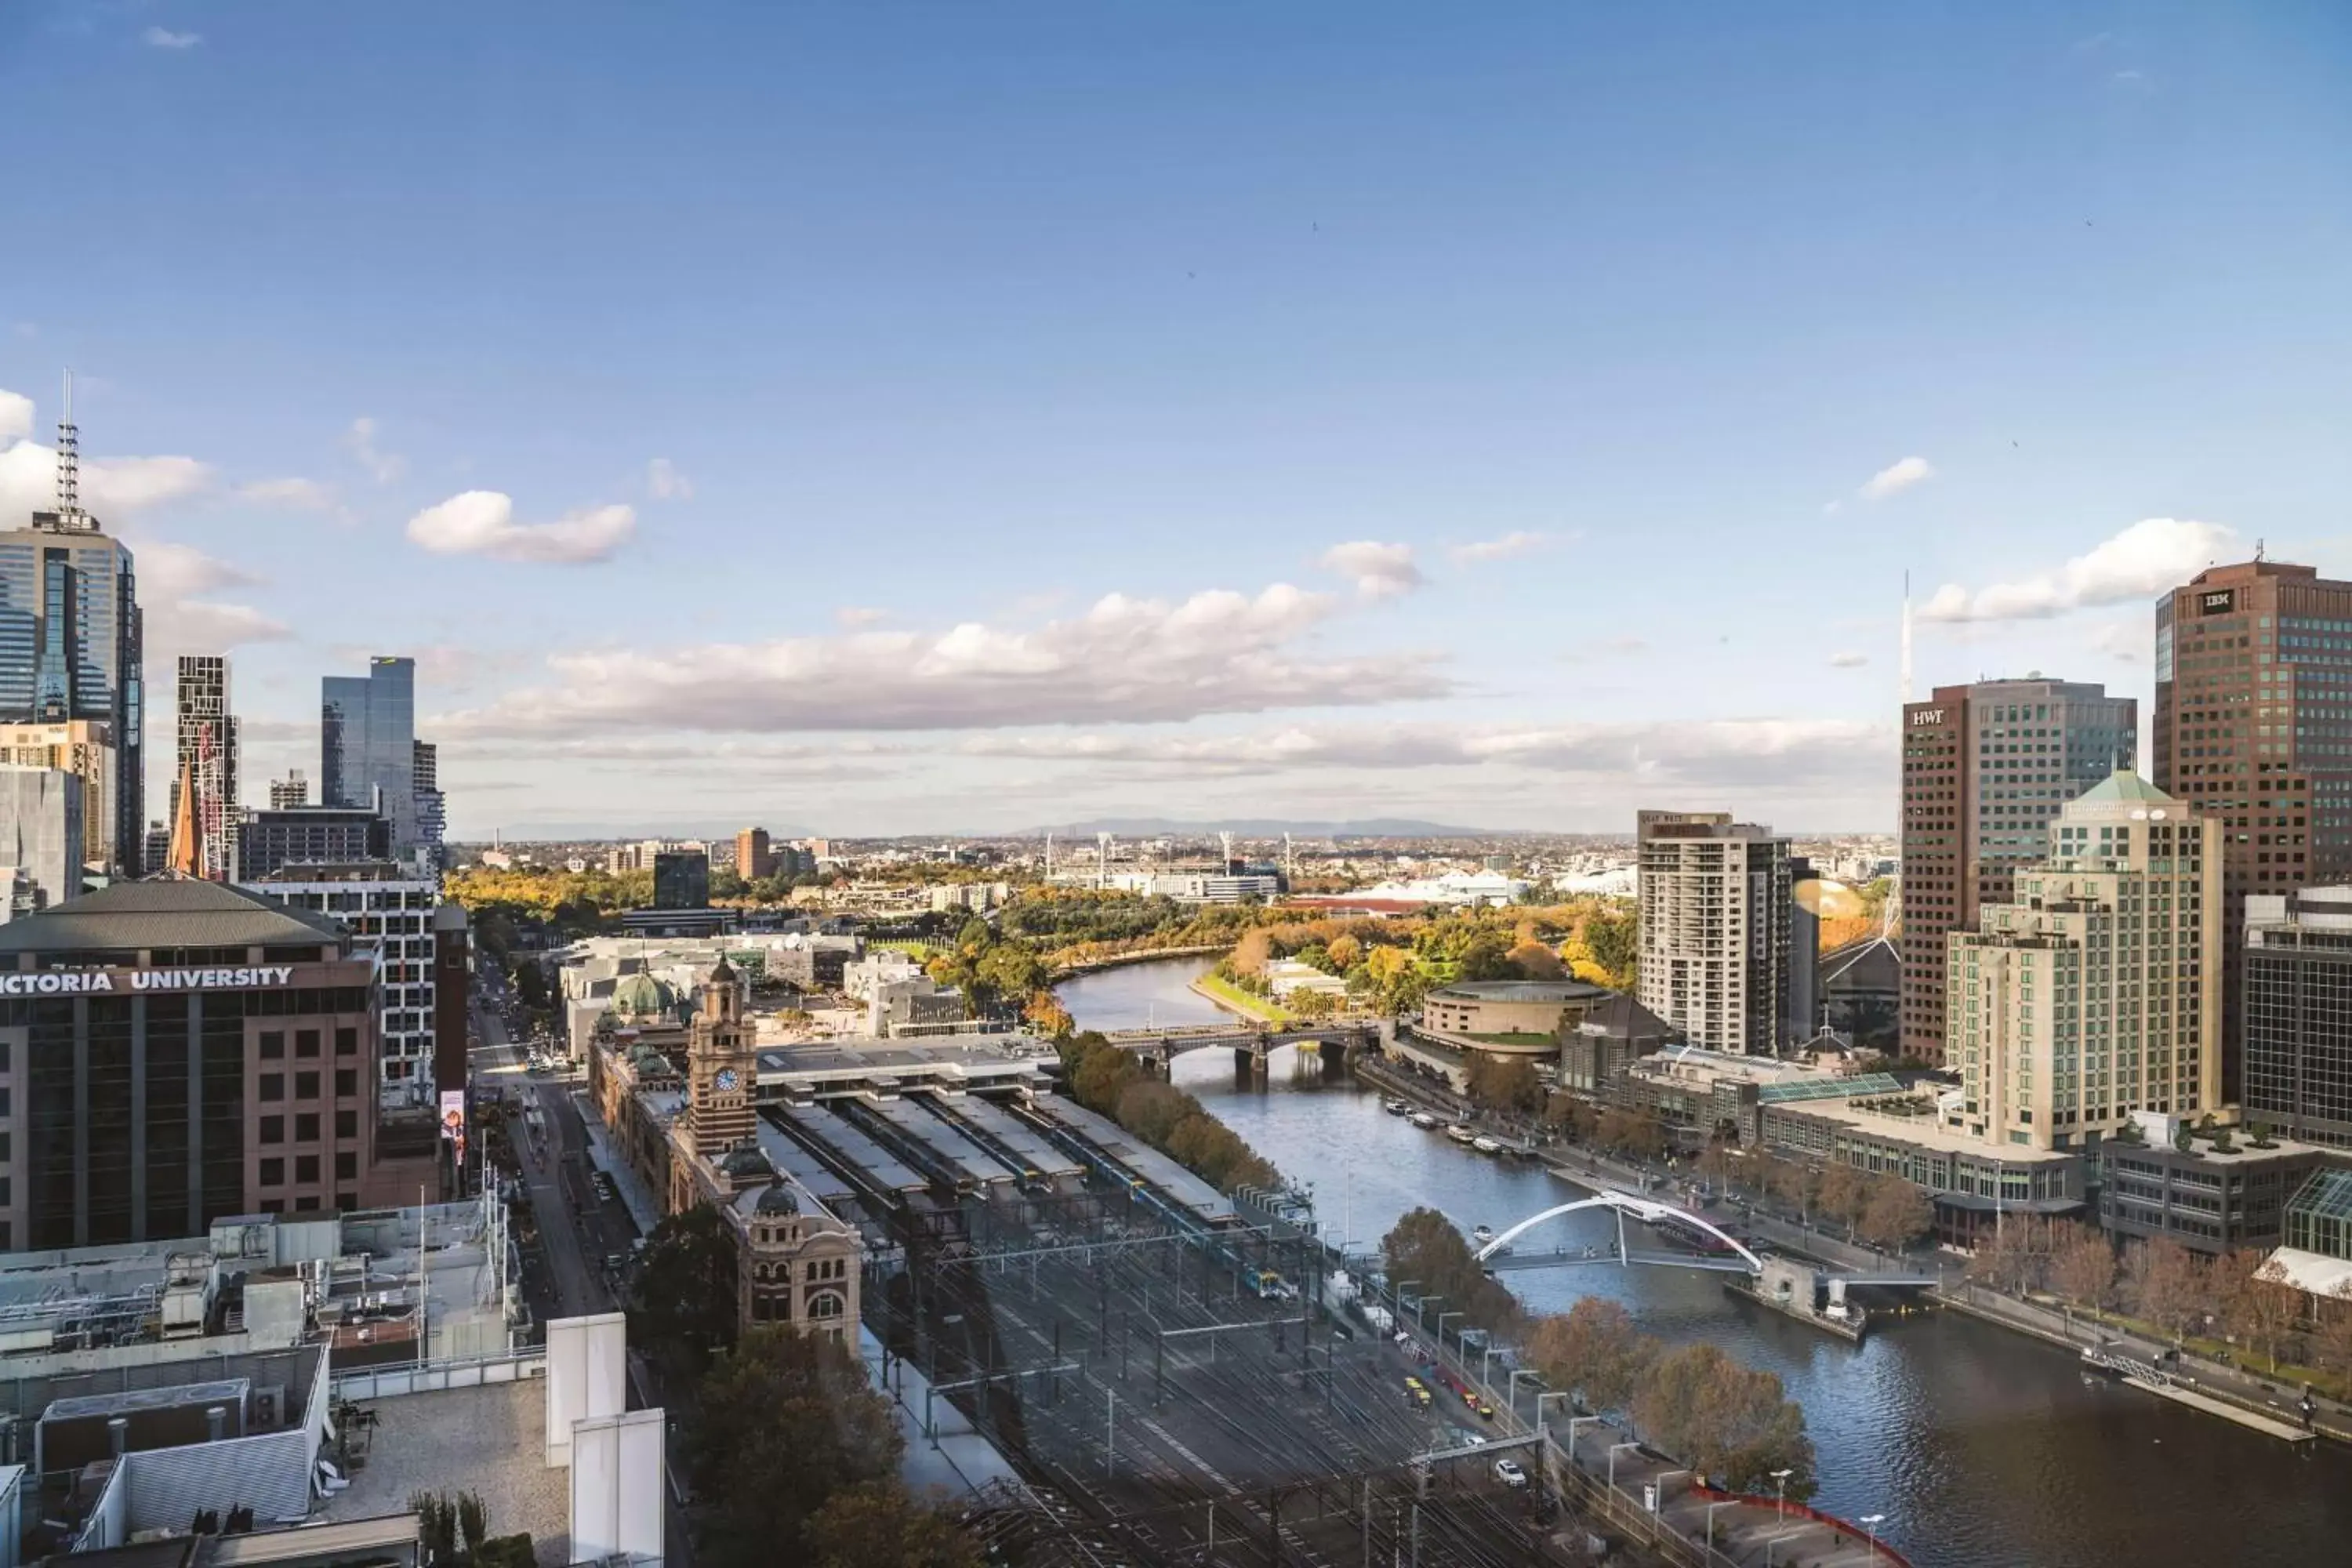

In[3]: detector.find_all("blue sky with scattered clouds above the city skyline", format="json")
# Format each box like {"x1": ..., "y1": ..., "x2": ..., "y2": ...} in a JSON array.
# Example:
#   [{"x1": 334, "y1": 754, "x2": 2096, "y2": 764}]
[{"x1": 0, "y1": 0, "x2": 2352, "y2": 834}]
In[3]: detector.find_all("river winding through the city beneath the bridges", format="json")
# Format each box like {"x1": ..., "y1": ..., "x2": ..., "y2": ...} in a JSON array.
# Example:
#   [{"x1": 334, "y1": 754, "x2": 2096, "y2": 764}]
[{"x1": 1061, "y1": 959, "x2": 2352, "y2": 1568}]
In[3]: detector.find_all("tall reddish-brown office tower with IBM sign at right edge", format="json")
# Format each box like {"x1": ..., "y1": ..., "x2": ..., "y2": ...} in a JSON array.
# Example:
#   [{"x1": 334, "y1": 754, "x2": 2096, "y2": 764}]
[{"x1": 2150, "y1": 560, "x2": 2352, "y2": 1093}]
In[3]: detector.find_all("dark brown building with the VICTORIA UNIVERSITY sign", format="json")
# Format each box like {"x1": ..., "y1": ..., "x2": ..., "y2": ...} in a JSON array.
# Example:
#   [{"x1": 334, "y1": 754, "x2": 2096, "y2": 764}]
[{"x1": 0, "y1": 881, "x2": 440, "y2": 1250}]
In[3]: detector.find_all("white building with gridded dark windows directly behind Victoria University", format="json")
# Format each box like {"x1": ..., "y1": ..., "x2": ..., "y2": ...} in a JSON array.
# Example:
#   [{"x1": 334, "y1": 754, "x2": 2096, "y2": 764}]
[{"x1": 249, "y1": 860, "x2": 445, "y2": 1105}]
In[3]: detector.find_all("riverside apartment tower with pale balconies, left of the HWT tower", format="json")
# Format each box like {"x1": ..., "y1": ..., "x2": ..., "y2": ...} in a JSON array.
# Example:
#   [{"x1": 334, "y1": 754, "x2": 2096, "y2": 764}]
[{"x1": 1637, "y1": 811, "x2": 1795, "y2": 1053}]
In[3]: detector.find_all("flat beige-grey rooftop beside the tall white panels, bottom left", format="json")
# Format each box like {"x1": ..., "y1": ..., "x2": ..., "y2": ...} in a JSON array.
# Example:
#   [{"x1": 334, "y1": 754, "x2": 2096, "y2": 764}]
[{"x1": 320, "y1": 1377, "x2": 572, "y2": 1568}]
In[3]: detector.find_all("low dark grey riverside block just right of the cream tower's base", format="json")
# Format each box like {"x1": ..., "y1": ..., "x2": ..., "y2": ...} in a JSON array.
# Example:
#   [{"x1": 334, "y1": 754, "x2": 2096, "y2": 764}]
[{"x1": 2098, "y1": 1112, "x2": 2326, "y2": 1253}]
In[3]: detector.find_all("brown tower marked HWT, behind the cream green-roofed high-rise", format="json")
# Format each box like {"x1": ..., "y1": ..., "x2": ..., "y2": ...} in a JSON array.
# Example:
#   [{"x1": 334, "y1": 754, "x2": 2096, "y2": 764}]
[{"x1": 1900, "y1": 675, "x2": 2140, "y2": 1065}]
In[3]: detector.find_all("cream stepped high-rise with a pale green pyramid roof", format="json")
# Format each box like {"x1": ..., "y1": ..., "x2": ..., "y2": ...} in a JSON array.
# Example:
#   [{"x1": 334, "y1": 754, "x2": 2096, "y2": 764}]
[{"x1": 1945, "y1": 771, "x2": 2223, "y2": 1149}]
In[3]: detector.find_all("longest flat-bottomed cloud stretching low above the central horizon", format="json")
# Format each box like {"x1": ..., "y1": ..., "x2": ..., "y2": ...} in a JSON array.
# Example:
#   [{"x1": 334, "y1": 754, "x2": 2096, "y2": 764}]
[{"x1": 437, "y1": 583, "x2": 1454, "y2": 736}]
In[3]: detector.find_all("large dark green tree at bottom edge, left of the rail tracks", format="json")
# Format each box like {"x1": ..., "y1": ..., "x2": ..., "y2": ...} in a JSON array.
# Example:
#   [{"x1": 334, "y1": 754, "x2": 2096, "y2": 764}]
[{"x1": 682, "y1": 1323, "x2": 908, "y2": 1568}]
